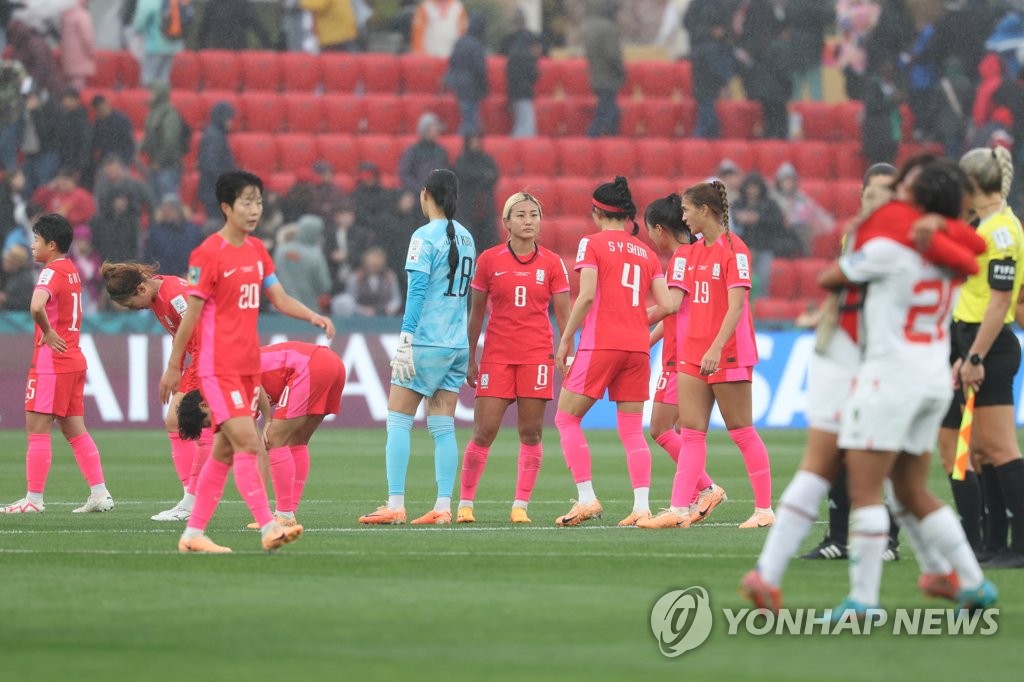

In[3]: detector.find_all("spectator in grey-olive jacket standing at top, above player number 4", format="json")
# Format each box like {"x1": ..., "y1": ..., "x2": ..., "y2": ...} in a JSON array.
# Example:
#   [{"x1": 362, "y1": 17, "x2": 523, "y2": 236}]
[{"x1": 583, "y1": 0, "x2": 626, "y2": 137}]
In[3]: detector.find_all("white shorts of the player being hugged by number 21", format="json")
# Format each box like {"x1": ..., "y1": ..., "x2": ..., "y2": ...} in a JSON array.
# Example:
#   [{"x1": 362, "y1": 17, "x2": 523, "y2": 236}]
[{"x1": 807, "y1": 329, "x2": 860, "y2": 433}]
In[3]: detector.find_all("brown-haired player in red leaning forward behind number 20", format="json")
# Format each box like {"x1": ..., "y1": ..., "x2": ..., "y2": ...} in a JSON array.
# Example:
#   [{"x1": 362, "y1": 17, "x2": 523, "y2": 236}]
[{"x1": 99, "y1": 262, "x2": 213, "y2": 521}]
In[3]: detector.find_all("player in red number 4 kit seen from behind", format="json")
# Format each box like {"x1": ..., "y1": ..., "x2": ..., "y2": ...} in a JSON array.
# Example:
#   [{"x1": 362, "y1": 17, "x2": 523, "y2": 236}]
[{"x1": 555, "y1": 176, "x2": 675, "y2": 526}]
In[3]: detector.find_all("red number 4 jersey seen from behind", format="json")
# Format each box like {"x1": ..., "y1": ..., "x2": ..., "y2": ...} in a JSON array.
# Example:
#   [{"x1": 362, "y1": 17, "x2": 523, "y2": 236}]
[{"x1": 575, "y1": 229, "x2": 665, "y2": 353}]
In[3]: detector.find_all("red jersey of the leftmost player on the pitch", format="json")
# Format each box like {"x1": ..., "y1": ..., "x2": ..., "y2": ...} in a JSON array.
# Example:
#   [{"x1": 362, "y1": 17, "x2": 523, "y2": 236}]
[{"x1": 32, "y1": 257, "x2": 86, "y2": 374}]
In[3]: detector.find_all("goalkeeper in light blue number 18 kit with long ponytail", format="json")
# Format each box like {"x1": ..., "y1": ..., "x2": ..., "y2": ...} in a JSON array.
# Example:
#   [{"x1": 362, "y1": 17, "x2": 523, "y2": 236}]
[{"x1": 359, "y1": 170, "x2": 476, "y2": 525}]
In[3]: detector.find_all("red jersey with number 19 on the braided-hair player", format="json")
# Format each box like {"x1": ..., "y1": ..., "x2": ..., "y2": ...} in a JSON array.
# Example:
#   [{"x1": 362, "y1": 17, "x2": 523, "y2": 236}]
[{"x1": 673, "y1": 233, "x2": 758, "y2": 369}]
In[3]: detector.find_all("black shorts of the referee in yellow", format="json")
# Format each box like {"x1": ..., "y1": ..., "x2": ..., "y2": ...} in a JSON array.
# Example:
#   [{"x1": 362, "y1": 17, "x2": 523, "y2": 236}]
[{"x1": 942, "y1": 322, "x2": 1021, "y2": 429}]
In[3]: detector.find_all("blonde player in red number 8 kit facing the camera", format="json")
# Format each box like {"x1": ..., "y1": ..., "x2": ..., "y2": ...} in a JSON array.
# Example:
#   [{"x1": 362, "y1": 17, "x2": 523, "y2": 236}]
[{"x1": 456, "y1": 191, "x2": 569, "y2": 523}]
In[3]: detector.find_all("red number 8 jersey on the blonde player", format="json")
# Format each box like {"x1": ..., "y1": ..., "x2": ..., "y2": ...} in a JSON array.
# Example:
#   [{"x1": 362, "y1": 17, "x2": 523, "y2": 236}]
[{"x1": 471, "y1": 244, "x2": 569, "y2": 365}]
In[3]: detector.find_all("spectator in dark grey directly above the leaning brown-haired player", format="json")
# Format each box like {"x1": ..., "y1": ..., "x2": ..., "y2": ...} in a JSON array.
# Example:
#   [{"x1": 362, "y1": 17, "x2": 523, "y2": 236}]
[{"x1": 92, "y1": 157, "x2": 156, "y2": 261}]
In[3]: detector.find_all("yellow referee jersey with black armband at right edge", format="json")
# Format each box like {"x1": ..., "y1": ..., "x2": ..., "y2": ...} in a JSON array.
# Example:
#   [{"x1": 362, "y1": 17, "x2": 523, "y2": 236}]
[{"x1": 953, "y1": 206, "x2": 1024, "y2": 324}]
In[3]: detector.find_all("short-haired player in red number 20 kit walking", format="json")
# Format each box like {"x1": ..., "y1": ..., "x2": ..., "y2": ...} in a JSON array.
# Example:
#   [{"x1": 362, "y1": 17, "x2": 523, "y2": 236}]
[{"x1": 160, "y1": 171, "x2": 334, "y2": 553}]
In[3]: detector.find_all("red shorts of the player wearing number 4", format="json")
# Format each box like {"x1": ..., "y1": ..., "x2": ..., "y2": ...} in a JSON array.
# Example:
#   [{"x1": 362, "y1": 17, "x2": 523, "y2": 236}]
[{"x1": 562, "y1": 350, "x2": 650, "y2": 402}]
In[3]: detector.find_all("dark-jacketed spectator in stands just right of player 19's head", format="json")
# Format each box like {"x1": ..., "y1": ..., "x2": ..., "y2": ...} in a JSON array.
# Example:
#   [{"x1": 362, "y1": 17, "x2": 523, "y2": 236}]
[{"x1": 729, "y1": 173, "x2": 803, "y2": 294}]
